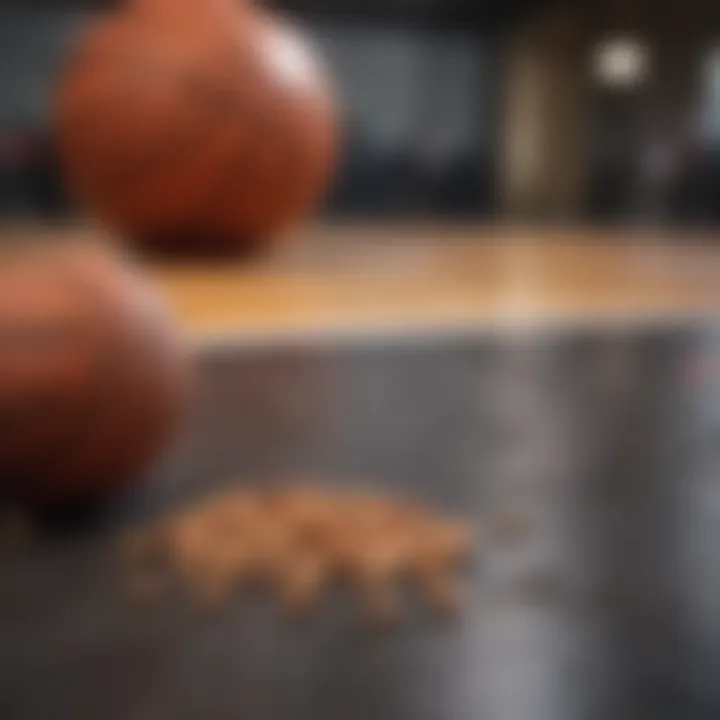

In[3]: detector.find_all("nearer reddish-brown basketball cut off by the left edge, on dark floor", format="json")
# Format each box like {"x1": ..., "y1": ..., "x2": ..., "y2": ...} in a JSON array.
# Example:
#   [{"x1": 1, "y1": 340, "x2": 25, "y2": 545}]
[{"x1": 0, "y1": 245, "x2": 189, "y2": 504}]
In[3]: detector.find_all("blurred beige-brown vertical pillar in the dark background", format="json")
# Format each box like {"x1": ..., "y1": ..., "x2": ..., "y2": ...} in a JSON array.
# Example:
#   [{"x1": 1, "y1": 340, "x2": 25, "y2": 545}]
[{"x1": 500, "y1": 5, "x2": 590, "y2": 219}]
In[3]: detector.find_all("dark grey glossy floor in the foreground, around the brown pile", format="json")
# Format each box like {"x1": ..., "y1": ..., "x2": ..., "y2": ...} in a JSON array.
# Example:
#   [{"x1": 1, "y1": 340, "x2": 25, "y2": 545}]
[{"x1": 0, "y1": 329, "x2": 720, "y2": 720}]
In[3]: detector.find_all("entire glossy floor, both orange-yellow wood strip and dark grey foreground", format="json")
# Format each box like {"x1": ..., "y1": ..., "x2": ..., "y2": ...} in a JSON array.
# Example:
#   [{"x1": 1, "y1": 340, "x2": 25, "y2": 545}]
[{"x1": 0, "y1": 227, "x2": 720, "y2": 720}]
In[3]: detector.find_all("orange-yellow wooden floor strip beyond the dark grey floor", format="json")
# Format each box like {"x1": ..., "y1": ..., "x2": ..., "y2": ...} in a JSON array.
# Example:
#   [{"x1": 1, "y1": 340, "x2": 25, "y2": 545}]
[{"x1": 153, "y1": 226, "x2": 720, "y2": 338}]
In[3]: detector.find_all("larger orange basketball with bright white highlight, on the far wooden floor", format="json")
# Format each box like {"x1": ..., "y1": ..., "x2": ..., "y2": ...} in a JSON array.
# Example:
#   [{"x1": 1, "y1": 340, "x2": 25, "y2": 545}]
[{"x1": 56, "y1": 0, "x2": 336, "y2": 254}]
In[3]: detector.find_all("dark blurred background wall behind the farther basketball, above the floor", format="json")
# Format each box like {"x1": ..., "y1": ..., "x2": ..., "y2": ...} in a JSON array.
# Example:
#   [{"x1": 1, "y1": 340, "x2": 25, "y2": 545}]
[{"x1": 0, "y1": 0, "x2": 720, "y2": 226}]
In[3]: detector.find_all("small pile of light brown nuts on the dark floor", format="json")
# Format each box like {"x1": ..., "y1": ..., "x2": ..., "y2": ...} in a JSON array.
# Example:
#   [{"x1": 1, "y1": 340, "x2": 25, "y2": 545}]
[{"x1": 122, "y1": 488, "x2": 471, "y2": 622}]
